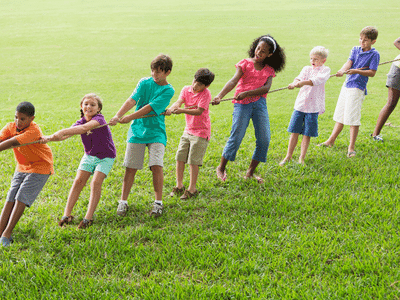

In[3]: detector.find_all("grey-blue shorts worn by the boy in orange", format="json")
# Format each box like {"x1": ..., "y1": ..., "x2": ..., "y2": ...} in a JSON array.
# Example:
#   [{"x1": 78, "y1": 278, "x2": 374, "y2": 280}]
[{"x1": 7, "y1": 172, "x2": 50, "y2": 207}]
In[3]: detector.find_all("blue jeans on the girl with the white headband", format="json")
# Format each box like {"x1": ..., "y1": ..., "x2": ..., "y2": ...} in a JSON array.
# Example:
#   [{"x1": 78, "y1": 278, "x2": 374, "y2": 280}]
[{"x1": 222, "y1": 97, "x2": 271, "y2": 162}]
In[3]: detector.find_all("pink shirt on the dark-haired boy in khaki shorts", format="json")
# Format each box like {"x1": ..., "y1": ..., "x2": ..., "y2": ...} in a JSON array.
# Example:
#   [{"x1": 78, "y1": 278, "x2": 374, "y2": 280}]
[{"x1": 179, "y1": 85, "x2": 211, "y2": 140}]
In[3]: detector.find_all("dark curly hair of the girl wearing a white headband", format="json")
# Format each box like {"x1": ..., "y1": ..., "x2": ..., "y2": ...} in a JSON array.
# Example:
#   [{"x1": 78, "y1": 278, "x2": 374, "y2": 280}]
[{"x1": 247, "y1": 34, "x2": 286, "y2": 73}]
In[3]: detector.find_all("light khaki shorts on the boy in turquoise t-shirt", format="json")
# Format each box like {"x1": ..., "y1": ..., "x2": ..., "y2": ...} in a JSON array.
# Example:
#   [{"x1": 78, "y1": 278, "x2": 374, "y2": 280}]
[{"x1": 124, "y1": 143, "x2": 165, "y2": 170}]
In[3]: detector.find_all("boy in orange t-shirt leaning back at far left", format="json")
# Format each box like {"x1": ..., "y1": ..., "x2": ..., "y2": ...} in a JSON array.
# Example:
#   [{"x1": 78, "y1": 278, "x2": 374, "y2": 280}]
[{"x1": 0, "y1": 102, "x2": 54, "y2": 247}]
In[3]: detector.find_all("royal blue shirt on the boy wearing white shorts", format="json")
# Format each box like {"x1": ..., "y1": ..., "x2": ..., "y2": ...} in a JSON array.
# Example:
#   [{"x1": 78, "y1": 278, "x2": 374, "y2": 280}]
[{"x1": 346, "y1": 46, "x2": 380, "y2": 95}]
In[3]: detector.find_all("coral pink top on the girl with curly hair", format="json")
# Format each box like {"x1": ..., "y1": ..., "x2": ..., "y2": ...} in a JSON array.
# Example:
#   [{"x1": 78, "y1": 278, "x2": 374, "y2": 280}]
[{"x1": 232, "y1": 58, "x2": 275, "y2": 104}]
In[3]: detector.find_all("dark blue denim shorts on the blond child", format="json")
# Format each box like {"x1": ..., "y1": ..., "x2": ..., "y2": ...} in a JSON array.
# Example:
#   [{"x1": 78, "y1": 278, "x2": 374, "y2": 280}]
[{"x1": 288, "y1": 110, "x2": 318, "y2": 137}]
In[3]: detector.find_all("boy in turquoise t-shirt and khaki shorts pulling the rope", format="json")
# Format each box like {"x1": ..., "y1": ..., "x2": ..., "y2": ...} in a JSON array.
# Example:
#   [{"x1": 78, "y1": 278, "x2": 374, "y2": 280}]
[{"x1": 109, "y1": 54, "x2": 175, "y2": 216}]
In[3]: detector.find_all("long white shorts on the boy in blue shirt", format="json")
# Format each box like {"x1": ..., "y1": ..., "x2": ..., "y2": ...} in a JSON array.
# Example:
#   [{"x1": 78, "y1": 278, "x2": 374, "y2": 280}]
[{"x1": 333, "y1": 83, "x2": 365, "y2": 126}]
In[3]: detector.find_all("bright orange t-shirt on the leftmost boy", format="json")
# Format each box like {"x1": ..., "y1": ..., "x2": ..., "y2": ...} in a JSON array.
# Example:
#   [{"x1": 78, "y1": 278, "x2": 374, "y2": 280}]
[{"x1": 0, "y1": 122, "x2": 54, "y2": 174}]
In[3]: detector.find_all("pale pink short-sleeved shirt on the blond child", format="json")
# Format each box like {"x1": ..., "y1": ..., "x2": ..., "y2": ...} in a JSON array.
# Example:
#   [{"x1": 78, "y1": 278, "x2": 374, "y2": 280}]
[{"x1": 294, "y1": 66, "x2": 331, "y2": 115}]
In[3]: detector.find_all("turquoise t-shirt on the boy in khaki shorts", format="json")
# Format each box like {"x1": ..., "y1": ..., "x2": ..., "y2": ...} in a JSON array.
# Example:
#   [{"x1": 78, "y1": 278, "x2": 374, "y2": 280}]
[{"x1": 127, "y1": 77, "x2": 175, "y2": 146}]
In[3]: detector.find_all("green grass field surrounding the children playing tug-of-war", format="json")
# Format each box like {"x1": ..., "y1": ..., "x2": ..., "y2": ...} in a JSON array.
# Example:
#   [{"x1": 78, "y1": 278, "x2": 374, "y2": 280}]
[{"x1": 0, "y1": 0, "x2": 400, "y2": 299}]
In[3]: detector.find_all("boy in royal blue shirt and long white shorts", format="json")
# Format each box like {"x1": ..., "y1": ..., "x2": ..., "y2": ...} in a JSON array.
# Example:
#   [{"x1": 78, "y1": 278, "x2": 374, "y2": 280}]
[{"x1": 318, "y1": 26, "x2": 380, "y2": 158}]
